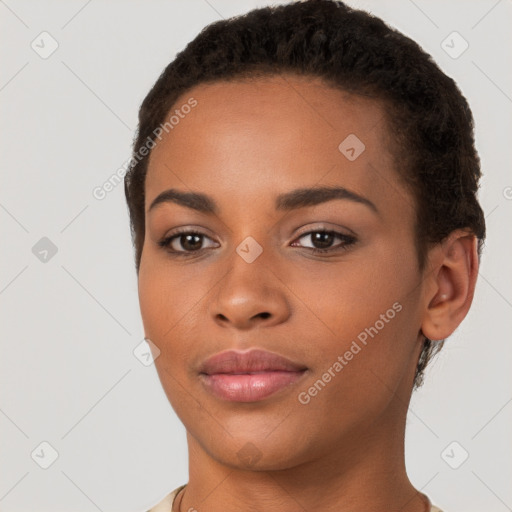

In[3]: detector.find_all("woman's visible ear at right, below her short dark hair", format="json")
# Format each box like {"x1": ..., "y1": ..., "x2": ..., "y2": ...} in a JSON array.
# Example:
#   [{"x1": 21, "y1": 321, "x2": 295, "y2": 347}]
[{"x1": 421, "y1": 230, "x2": 479, "y2": 340}]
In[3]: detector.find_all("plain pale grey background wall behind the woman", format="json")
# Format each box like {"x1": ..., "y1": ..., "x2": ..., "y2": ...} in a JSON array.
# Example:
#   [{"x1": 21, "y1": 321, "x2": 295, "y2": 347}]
[{"x1": 0, "y1": 0, "x2": 512, "y2": 512}]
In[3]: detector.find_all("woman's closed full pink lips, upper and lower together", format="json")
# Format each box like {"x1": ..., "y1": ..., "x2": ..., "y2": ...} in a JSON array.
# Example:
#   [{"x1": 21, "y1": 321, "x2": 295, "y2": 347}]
[{"x1": 200, "y1": 349, "x2": 308, "y2": 402}]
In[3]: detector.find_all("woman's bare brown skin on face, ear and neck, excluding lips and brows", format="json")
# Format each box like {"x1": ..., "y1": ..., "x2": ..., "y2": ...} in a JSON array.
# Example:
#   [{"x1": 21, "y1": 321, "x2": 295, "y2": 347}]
[{"x1": 139, "y1": 75, "x2": 478, "y2": 512}]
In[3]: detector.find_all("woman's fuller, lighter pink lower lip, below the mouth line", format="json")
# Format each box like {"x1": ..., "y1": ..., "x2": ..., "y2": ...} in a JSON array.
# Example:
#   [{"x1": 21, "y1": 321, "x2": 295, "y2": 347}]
[{"x1": 201, "y1": 370, "x2": 306, "y2": 402}]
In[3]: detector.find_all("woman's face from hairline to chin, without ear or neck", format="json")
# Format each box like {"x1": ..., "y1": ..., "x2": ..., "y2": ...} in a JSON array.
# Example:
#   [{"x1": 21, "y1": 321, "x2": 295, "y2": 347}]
[{"x1": 139, "y1": 75, "x2": 423, "y2": 469}]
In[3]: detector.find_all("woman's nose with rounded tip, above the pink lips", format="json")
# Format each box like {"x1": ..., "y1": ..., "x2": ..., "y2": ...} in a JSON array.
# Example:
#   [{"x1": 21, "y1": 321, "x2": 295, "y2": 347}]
[{"x1": 210, "y1": 250, "x2": 290, "y2": 330}]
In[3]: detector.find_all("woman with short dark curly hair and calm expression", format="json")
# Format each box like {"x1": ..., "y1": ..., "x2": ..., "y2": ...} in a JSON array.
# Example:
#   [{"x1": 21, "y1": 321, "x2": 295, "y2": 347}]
[{"x1": 125, "y1": 0, "x2": 485, "y2": 512}]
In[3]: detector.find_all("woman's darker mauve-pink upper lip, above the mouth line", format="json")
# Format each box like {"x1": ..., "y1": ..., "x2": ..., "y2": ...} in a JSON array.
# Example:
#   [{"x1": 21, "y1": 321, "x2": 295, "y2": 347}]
[{"x1": 199, "y1": 349, "x2": 307, "y2": 375}]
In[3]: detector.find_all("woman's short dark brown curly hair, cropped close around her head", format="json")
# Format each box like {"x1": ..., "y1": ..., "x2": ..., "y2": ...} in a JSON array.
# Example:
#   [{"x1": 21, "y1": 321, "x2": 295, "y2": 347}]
[{"x1": 125, "y1": 0, "x2": 485, "y2": 389}]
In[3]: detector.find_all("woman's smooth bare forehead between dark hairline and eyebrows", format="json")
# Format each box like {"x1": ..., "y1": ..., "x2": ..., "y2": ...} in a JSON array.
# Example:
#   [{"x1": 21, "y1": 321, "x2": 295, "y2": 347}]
[{"x1": 146, "y1": 75, "x2": 403, "y2": 218}]
